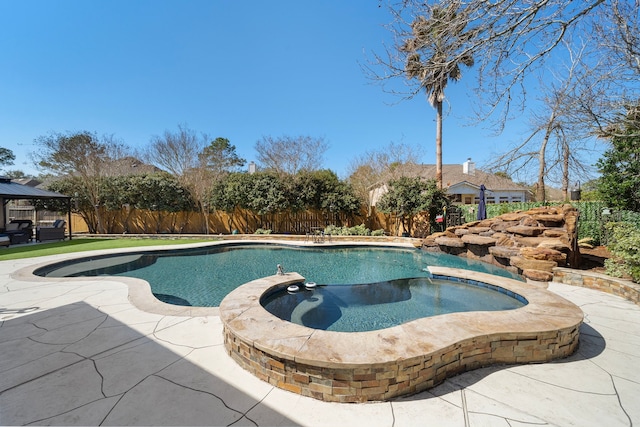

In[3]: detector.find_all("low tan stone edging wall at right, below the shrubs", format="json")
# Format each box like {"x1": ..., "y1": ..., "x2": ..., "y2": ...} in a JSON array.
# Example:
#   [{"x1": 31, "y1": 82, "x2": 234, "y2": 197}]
[{"x1": 553, "y1": 267, "x2": 640, "y2": 305}]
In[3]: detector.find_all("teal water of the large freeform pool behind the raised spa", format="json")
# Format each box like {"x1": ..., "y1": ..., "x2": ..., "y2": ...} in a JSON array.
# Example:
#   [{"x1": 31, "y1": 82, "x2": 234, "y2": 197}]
[{"x1": 35, "y1": 243, "x2": 518, "y2": 307}]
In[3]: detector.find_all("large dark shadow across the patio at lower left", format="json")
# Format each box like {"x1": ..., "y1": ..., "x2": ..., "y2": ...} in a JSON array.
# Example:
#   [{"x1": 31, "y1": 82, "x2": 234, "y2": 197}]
[{"x1": 0, "y1": 302, "x2": 295, "y2": 425}]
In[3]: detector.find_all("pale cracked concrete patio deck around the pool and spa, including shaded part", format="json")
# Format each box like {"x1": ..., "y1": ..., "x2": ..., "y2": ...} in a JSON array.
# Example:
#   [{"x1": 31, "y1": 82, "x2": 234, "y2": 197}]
[{"x1": 0, "y1": 246, "x2": 640, "y2": 427}]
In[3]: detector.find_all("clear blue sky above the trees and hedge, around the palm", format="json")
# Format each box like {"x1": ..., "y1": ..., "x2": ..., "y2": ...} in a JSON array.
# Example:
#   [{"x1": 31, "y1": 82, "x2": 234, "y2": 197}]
[{"x1": 0, "y1": 0, "x2": 584, "y2": 178}]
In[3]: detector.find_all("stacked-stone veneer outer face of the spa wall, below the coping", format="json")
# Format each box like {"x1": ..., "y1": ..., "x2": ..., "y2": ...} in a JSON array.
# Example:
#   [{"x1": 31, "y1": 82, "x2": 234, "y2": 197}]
[{"x1": 225, "y1": 328, "x2": 578, "y2": 403}]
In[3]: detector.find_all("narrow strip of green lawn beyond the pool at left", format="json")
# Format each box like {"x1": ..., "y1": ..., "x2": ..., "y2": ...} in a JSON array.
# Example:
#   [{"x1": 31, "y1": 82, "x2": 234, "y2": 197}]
[{"x1": 0, "y1": 238, "x2": 212, "y2": 261}]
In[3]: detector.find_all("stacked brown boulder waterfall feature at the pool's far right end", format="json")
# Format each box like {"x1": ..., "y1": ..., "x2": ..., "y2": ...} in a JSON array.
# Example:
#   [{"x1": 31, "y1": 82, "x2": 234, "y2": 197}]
[{"x1": 423, "y1": 205, "x2": 580, "y2": 282}]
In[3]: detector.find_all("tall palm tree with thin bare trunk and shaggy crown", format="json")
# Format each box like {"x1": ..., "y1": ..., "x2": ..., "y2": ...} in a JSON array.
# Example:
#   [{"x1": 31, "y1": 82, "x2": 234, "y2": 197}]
[{"x1": 401, "y1": 4, "x2": 474, "y2": 188}]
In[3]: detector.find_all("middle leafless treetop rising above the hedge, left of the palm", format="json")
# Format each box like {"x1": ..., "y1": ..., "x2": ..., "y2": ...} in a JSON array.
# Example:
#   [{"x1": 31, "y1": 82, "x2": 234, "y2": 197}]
[{"x1": 255, "y1": 135, "x2": 329, "y2": 175}]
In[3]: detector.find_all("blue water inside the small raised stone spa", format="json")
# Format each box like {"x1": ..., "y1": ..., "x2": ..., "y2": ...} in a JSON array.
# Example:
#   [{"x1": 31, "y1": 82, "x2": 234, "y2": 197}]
[{"x1": 261, "y1": 278, "x2": 526, "y2": 332}]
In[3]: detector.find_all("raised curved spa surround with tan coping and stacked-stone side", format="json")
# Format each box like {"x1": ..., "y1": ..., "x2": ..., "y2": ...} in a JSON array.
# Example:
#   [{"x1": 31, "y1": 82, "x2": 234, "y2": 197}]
[{"x1": 220, "y1": 267, "x2": 583, "y2": 402}]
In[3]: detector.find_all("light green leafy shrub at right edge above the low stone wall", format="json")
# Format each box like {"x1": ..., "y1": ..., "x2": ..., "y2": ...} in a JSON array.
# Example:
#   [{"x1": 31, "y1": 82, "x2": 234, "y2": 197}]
[{"x1": 605, "y1": 222, "x2": 640, "y2": 283}]
